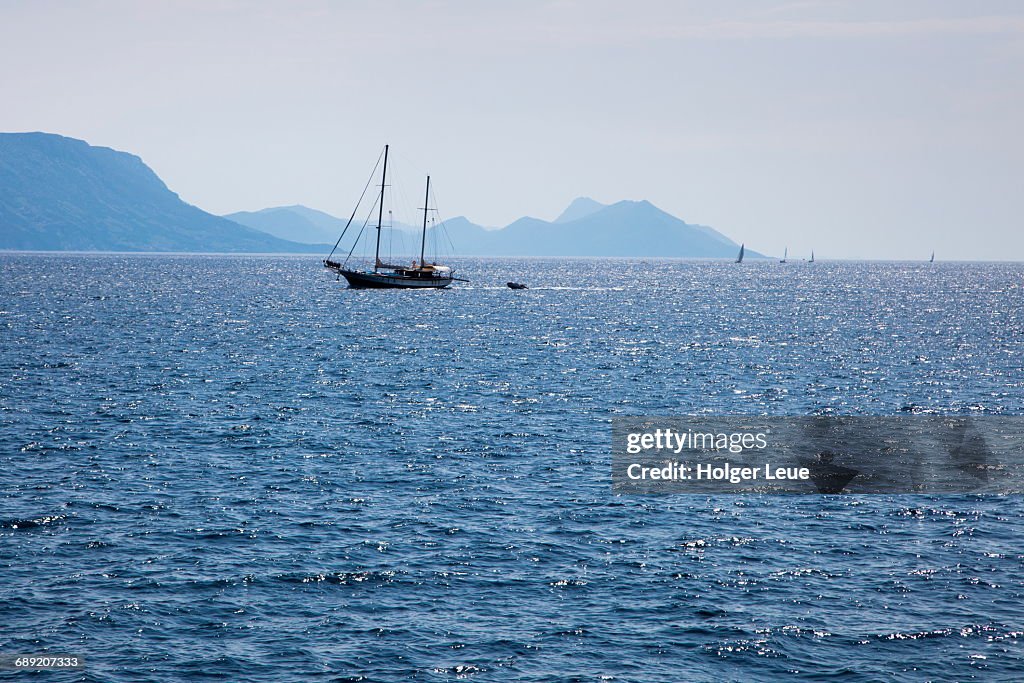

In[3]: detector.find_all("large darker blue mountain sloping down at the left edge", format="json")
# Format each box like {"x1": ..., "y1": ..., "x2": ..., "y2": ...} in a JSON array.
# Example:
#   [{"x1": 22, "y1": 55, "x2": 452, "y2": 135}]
[{"x1": 0, "y1": 133, "x2": 319, "y2": 252}]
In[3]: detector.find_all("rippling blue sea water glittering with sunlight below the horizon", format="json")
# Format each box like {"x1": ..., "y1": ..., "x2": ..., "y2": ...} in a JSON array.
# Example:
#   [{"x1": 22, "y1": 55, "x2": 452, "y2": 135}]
[{"x1": 0, "y1": 254, "x2": 1024, "y2": 682}]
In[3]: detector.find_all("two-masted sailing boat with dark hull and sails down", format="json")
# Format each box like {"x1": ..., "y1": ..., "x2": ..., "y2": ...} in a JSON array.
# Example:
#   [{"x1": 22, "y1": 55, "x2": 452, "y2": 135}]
[{"x1": 324, "y1": 144, "x2": 467, "y2": 289}]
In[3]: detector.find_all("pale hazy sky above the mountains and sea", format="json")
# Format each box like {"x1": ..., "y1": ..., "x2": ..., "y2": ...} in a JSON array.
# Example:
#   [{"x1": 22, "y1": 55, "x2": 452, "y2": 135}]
[{"x1": 0, "y1": 0, "x2": 1024, "y2": 260}]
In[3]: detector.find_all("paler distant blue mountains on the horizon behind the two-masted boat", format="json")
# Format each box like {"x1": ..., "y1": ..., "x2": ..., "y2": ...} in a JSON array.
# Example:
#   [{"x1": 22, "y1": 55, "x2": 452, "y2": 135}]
[{"x1": 228, "y1": 198, "x2": 764, "y2": 259}]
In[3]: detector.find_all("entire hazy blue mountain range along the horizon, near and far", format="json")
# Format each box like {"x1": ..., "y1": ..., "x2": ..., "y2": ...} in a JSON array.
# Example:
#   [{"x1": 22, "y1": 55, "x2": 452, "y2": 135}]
[{"x1": 0, "y1": 133, "x2": 761, "y2": 258}]
